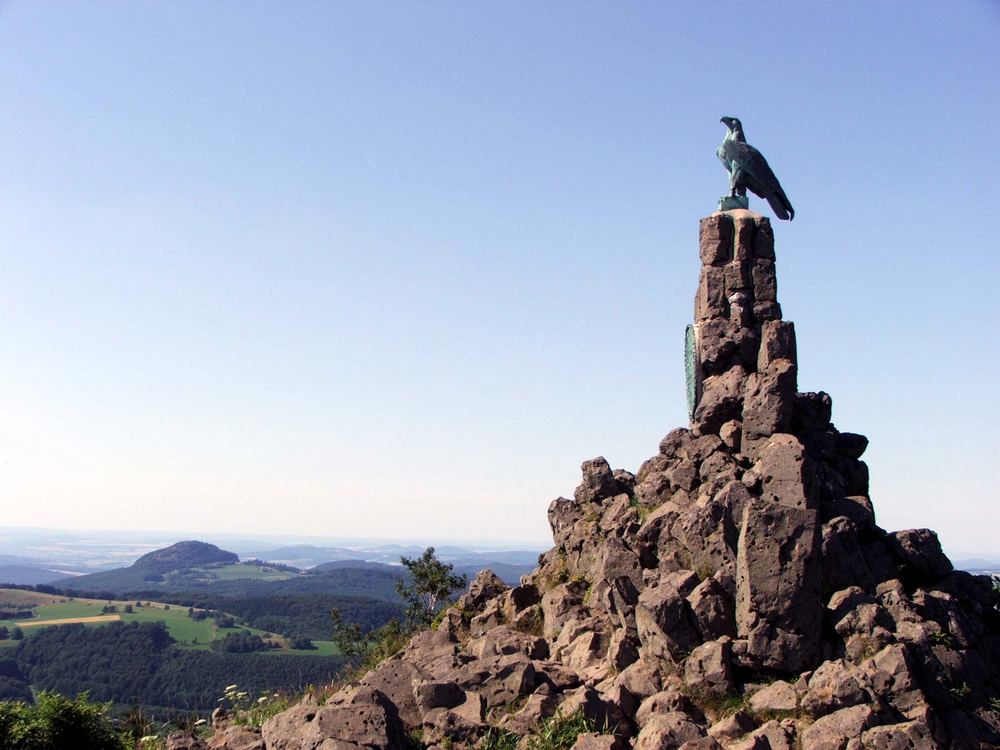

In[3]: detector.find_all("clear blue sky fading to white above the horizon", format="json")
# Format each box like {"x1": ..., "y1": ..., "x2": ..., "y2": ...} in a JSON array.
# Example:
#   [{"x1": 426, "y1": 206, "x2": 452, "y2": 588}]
[{"x1": 0, "y1": 0, "x2": 1000, "y2": 552}]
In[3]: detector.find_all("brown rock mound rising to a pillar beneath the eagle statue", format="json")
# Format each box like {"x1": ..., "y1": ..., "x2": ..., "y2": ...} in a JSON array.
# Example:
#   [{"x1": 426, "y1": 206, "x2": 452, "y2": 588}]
[{"x1": 184, "y1": 210, "x2": 1000, "y2": 750}]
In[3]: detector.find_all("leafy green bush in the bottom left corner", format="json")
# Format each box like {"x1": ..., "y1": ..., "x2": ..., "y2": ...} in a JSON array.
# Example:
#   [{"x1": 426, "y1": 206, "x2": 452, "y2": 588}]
[{"x1": 0, "y1": 692, "x2": 130, "y2": 750}]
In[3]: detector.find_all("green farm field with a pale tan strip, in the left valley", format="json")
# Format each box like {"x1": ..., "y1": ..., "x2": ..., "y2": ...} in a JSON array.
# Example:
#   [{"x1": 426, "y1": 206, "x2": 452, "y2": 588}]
[{"x1": 0, "y1": 589, "x2": 338, "y2": 656}]
